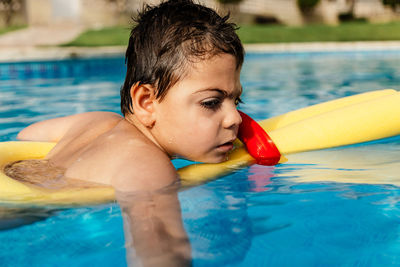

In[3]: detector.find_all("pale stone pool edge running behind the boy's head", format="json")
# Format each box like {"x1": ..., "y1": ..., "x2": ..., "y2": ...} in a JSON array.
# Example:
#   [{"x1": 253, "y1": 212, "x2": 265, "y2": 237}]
[{"x1": 0, "y1": 41, "x2": 400, "y2": 62}]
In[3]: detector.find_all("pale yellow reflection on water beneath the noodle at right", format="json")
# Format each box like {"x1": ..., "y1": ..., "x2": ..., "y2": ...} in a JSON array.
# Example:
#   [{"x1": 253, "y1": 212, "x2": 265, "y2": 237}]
[{"x1": 277, "y1": 138, "x2": 400, "y2": 186}]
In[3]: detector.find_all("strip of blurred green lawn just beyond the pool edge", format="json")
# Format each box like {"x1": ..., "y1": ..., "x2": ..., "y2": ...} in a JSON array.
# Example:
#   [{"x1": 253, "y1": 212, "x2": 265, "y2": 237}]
[{"x1": 65, "y1": 22, "x2": 400, "y2": 46}]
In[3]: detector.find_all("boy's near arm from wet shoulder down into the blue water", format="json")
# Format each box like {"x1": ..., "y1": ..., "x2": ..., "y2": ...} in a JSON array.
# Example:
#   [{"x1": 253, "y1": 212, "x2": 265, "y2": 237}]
[{"x1": 113, "y1": 149, "x2": 191, "y2": 267}]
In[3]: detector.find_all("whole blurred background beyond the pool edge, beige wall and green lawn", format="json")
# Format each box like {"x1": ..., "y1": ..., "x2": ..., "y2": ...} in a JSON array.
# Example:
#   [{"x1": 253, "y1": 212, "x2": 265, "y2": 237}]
[{"x1": 0, "y1": 0, "x2": 400, "y2": 48}]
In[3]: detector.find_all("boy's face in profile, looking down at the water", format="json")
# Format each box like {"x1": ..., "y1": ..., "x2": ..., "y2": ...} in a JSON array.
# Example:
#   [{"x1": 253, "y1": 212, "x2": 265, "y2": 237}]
[{"x1": 153, "y1": 54, "x2": 242, "y2": 163}]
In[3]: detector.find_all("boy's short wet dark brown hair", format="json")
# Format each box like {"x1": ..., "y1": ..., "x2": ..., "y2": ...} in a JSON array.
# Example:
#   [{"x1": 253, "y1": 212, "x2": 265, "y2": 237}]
[{"x1": 121, "y1": 0, "x2": 244, "y2": 115}]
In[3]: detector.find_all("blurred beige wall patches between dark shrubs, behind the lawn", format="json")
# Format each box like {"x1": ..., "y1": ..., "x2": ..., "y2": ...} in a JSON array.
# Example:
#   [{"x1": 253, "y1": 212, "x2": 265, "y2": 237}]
[{"x1": 21, "y1": 0, "x2": 400, "y2": 27}]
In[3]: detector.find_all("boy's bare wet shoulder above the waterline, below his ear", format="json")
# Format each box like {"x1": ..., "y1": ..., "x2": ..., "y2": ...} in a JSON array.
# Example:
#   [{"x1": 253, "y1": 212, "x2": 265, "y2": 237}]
[{"x1": 111, "y1": 140, "x2": 178, "y2": 192}]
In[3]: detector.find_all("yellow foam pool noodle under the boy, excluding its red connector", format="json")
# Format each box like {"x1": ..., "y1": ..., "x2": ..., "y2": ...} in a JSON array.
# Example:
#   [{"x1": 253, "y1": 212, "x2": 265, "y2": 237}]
[{"x1": 0, "y1": 89, "x2": 400, "y2": 205}]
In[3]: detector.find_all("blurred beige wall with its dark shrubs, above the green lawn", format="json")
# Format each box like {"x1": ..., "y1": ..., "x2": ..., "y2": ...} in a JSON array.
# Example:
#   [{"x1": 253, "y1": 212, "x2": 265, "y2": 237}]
[{"x1": 0, "y1": 0, "x2": 400, "y2": 27}]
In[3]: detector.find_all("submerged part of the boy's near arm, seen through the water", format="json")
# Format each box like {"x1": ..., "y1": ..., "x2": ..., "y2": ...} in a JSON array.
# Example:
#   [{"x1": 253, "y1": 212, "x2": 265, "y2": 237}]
[{"x1": 116, "y1": 184, "x2": 191, "y2": 267}]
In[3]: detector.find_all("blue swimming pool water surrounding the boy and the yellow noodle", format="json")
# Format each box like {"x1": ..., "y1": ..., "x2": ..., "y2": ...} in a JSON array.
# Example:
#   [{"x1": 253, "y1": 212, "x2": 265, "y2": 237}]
[{"x1": 0, "y1": 51, "x2": 400, "y2": 266}]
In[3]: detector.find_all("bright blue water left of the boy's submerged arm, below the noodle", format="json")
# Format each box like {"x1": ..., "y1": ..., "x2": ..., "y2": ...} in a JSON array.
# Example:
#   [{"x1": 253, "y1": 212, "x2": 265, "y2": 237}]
[{"x1": 0, "y1": 204, "x2": 126, "y2": 266}]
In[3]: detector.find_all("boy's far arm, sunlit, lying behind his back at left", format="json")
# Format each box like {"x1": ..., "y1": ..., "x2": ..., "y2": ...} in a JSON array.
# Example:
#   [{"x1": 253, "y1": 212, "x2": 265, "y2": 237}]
[{"x1": 17, "y1": 112, "x2": 120, "y2": 142}]
